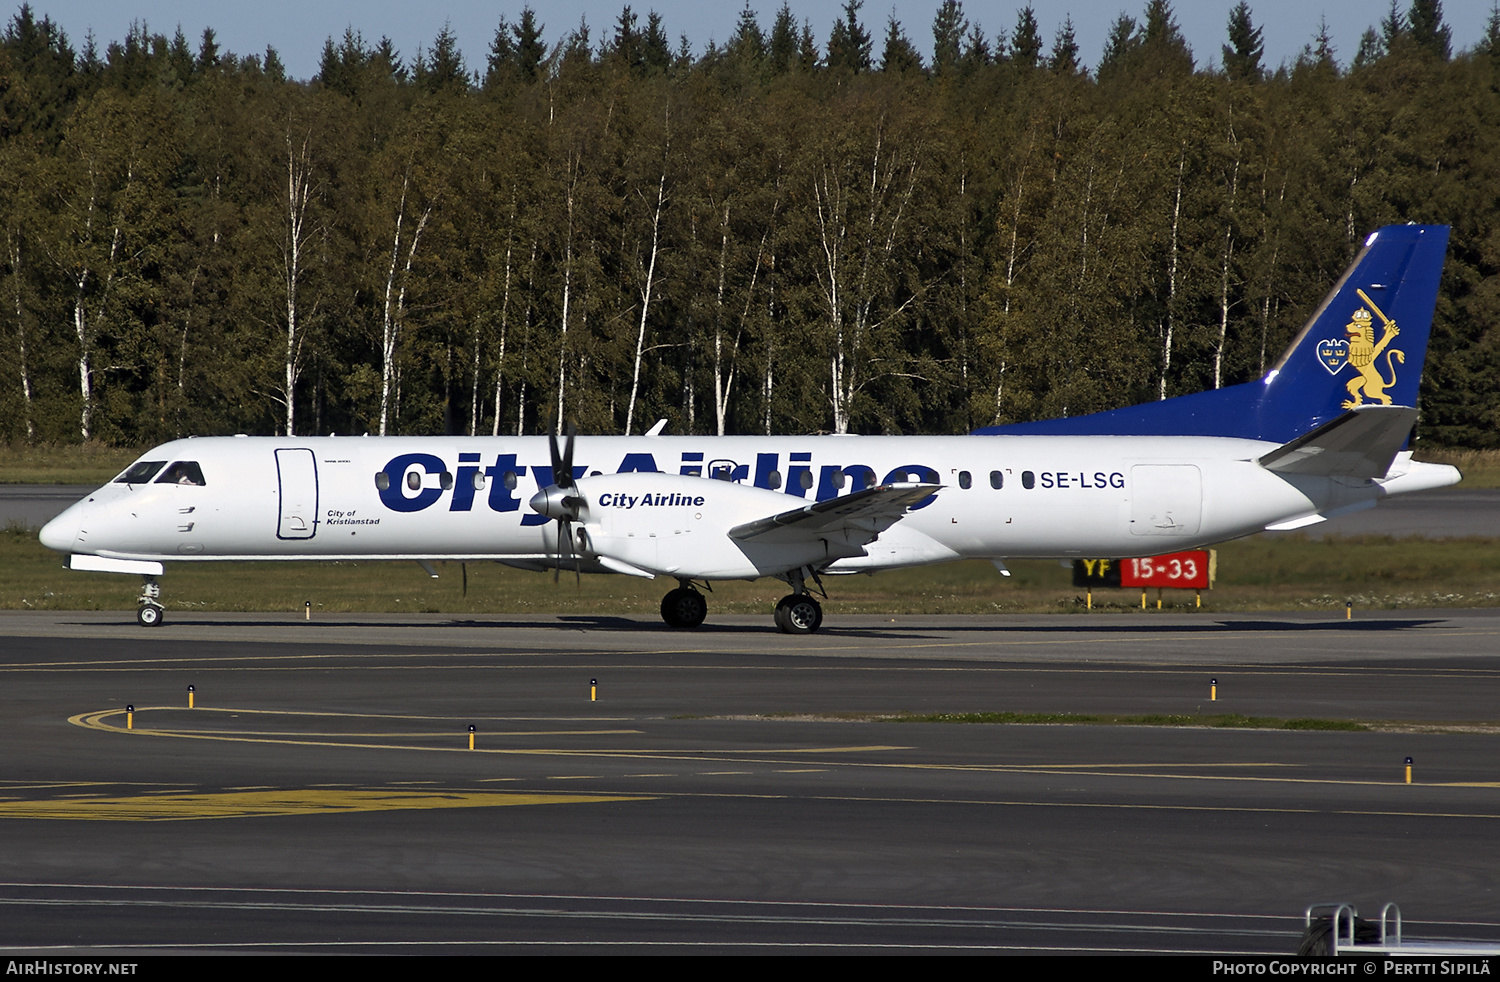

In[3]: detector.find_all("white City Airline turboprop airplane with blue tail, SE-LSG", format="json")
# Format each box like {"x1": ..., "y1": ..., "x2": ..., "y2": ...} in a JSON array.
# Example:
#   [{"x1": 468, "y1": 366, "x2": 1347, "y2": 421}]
[{"x1": 41, "y1": 225, "x2": 1460, "y2": 634}]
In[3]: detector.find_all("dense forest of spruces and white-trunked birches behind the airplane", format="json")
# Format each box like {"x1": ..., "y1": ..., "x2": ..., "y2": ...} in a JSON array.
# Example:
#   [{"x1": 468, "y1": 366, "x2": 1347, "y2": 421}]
[{"x1": 0, "y1": 0, "x2": 1500, "y2": 448}]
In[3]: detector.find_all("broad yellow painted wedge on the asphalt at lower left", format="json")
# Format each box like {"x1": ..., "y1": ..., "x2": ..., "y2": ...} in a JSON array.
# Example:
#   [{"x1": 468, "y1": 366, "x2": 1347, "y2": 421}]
[{"x1": 0, "y1": 789, "x2": 651, "y2": 822}]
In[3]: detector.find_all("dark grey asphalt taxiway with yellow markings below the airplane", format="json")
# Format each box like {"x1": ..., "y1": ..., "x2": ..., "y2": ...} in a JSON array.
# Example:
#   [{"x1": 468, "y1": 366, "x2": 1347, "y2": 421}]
[{"x1": 0, "y1": 607, "x2": 1500, "y2": 954}]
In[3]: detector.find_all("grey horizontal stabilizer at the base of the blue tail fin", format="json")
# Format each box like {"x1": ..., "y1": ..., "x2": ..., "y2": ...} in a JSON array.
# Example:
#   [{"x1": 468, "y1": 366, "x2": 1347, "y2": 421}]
[{"x1": 1260, "y1": 406, "x2": 1416, "y2": 480}]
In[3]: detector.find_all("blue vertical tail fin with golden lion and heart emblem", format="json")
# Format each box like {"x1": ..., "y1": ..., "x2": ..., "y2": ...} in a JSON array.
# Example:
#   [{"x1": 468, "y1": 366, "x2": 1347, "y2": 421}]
[{"x1": 975, "y1": 225, "x2": 1448, "y2": 444}]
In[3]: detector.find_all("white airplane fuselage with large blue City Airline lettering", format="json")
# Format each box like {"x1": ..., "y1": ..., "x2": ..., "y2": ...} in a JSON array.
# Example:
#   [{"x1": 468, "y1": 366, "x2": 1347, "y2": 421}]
[{"x1": 44, "y1": 436, "x2": 1458, "y2": 576}]
